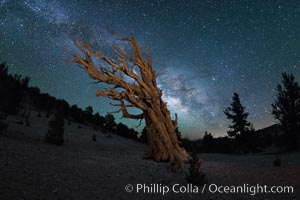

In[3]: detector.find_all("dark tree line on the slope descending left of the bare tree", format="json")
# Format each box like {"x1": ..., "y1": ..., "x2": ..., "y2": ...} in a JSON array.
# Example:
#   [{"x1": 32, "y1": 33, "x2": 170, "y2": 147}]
[{"x1": 0, "y1": 62, "x2": 139, "y2": 143}]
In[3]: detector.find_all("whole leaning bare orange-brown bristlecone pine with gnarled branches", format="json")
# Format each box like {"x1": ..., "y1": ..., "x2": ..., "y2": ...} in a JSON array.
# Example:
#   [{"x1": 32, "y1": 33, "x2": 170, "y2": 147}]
[{"x1": 70, "y1": 36, "x2": 189, "y2": 170}]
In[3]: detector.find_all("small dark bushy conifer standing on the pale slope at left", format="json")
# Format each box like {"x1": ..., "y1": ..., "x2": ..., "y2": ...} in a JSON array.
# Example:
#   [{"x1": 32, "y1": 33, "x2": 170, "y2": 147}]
[{"x1": 45, "y1": 110, "x2": 65, "y2": 145}]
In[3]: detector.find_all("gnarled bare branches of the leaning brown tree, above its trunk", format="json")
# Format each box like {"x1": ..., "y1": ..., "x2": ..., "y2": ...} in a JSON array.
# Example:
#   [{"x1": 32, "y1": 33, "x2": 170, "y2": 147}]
[{"x1": 69, "y1": 37, "x2": 152, "y2": 110}]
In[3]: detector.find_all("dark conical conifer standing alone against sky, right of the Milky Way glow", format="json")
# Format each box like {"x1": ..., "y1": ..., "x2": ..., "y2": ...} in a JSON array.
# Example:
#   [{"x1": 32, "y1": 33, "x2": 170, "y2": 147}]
[{"x1": 224, "y1": 93, "x2": 251, "y2": 138}]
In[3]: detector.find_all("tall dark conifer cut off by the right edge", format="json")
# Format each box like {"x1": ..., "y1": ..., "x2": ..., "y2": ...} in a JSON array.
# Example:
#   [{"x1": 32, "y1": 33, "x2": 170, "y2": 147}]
[{"x1": 272, "y1": 73, "x2": 300, "y2": 150}]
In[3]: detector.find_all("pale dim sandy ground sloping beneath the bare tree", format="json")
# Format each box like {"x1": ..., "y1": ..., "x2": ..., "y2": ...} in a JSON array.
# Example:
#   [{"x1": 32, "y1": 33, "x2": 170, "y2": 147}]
[{"x1": 0, "y1": 111, "x2": 300, "y2": 200}]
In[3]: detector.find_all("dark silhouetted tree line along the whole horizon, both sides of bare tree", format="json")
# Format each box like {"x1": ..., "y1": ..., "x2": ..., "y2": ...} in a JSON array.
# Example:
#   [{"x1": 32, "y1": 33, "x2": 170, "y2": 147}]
[{"x1": 0, "y1": 59, "x2": 300, "y2": 153}]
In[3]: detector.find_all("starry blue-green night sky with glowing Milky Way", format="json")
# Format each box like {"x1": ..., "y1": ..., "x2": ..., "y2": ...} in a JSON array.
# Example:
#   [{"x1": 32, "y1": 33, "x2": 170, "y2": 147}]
[{"x1": 0, "y1": 0, "x2": 300, "y2": 139}]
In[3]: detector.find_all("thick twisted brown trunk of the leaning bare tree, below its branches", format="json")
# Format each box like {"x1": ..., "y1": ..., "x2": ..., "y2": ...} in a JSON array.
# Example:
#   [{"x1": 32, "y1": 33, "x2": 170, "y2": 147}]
[{"x1": 144, "y1": 88, "x2": 189, "y2": 170}]
